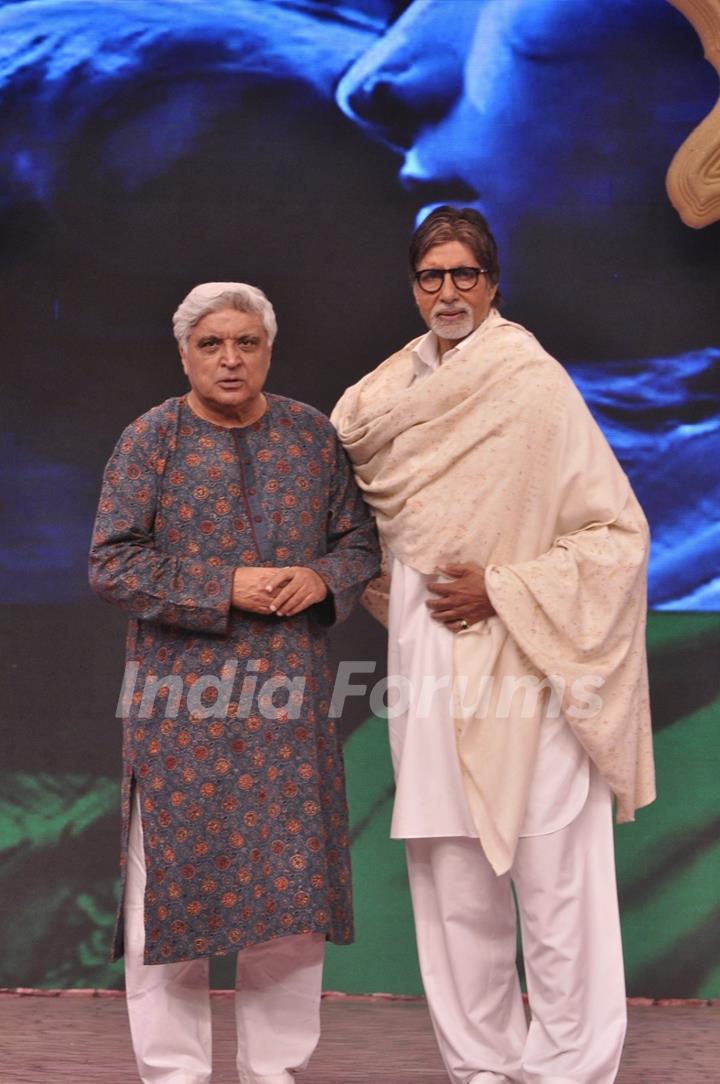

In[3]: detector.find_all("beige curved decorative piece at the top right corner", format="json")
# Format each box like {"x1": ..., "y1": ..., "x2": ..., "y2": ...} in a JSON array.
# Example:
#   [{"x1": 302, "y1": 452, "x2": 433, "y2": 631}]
[{"x1": 665, "y1": 0, "x2": 720, "y2": 230}]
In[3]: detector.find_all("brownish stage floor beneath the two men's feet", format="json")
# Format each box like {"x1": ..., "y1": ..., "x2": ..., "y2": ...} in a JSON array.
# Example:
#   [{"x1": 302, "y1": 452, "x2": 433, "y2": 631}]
[{"x1": 0, "y1": 991, "x2": 720, "y2": 1084}]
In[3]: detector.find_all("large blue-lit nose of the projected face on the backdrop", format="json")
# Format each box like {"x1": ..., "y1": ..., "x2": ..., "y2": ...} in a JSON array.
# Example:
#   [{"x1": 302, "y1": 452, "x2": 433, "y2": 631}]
[{"x1": 336, "y1": 0, "x2": 470, "y2": 149}]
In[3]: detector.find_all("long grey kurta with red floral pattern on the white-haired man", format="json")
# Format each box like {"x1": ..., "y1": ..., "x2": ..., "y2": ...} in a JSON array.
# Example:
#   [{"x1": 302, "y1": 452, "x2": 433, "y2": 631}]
[{"x1": 90, "y1": 395, "x2": 378, "y2": 964}]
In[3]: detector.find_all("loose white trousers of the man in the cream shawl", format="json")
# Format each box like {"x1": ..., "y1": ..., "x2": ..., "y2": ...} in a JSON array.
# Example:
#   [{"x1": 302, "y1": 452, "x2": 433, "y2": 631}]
[{"x1": 406, "y1": 769, "x2": 627, "y2": 1084}]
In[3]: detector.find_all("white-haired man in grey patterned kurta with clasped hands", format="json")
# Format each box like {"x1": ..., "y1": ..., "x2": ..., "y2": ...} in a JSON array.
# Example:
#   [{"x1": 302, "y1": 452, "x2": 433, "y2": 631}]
[{"x1": 90, "y1": 283, "x2": 378, "y2": 1084}]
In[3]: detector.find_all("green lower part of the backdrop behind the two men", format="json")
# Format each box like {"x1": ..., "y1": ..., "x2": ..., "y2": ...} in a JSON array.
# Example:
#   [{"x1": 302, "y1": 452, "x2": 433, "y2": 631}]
[{"x1": 0, "y1": 614, "x2": 720, "y2": 997}]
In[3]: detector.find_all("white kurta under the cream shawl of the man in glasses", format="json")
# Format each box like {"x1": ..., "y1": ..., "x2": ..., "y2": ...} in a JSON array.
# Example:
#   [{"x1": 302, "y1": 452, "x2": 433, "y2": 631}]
[{"x1": 388, "y1": 332, "x2": 589, "y2": 839}]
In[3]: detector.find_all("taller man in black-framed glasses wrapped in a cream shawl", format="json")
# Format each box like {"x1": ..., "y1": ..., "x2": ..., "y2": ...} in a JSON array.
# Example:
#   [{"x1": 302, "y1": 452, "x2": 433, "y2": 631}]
[{"x1": 333, "y1": 206, "x2": 654, "y2": 1084}]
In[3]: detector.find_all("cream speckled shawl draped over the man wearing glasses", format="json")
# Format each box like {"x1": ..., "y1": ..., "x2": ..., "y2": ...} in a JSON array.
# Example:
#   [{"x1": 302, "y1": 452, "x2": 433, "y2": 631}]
[{"x1": 333, "y1": 310, "x2": 655, "y2": 873}]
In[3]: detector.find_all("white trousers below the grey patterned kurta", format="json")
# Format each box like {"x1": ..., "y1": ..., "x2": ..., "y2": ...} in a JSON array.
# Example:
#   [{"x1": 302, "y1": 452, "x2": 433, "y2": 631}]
[{"x1": 124, "y1": 788, "x2": 324, "y2": 1084}]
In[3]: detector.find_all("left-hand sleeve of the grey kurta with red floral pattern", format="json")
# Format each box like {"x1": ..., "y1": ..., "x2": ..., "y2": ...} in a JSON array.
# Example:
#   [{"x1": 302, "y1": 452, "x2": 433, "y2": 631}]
[{"x1": 90, "y1": 418, "x2": 234, "y2": 633}]
